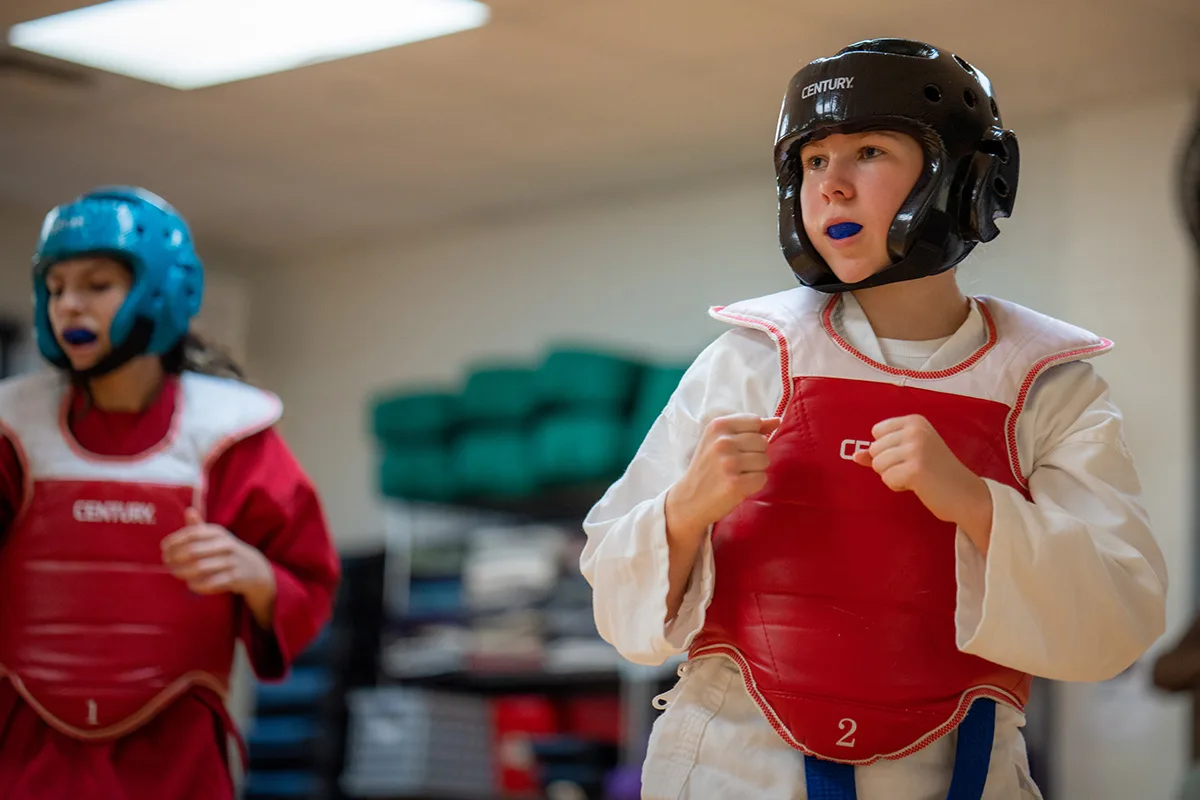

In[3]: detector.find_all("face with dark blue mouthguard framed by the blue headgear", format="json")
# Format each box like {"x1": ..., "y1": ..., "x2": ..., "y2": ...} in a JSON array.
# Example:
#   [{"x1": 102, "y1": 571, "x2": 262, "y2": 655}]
[{"x1": 46, "y1": 257, "x2": 133, "y2": 369}]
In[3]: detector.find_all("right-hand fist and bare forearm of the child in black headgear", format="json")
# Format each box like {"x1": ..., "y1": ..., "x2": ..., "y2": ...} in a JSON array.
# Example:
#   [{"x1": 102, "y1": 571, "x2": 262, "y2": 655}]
[{"x1": 854, "y1": 415, "x2": 992, "y2": 552}]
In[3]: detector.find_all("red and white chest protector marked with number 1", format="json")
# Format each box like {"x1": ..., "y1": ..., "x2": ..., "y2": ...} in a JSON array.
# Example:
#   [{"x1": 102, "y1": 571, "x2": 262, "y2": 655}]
[{"x1": 0, "y1": 374, "x2": 280, "y2": 740}]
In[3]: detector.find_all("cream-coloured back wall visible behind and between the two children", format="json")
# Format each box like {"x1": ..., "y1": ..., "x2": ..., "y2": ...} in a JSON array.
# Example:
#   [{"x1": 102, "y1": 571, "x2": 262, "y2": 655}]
[{"x1": 251, "y1": 95, "x2": 1196, "y2": 800}]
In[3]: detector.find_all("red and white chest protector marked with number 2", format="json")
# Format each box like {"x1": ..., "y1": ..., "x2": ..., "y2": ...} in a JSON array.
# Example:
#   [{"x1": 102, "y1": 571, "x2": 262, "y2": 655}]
[{"x1": 690, "y1": 290, "x2": 1111, "y2": 764}]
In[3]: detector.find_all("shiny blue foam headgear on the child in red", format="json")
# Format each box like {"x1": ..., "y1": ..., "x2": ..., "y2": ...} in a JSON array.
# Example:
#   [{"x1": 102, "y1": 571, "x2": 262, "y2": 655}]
[{"x1": 34, "y1": 186, "x2": 204, "y2": 368}]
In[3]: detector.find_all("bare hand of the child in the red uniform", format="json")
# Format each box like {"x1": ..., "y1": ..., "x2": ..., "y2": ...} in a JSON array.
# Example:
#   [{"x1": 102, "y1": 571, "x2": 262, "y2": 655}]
[{"x1": 162, "y1": 509, "x2": 275, "y2": 599}]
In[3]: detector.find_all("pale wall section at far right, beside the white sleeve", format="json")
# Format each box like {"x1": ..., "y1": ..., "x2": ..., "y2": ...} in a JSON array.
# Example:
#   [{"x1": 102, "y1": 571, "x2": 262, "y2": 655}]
[{"x1": 1056, "y1": 90, "x2": 1200, "y2": 800}]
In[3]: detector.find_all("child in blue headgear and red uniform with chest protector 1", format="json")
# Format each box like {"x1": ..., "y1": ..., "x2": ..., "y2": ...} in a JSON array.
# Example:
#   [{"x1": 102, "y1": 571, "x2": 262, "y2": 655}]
[{"x1": 0, "y1": 187, "x2": 340, "y2": 800}]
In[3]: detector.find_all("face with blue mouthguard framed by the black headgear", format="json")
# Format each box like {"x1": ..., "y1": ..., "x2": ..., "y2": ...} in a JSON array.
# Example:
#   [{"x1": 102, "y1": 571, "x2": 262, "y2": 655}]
[{"x1": 800, "y1": 131, "x2": 925, "y2": 283}]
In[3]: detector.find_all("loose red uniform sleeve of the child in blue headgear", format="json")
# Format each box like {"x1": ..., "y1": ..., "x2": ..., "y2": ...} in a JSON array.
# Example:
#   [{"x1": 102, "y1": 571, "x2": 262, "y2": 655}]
[{"x1": 206, "y1": 429, "x2": 341, "y2": 680}]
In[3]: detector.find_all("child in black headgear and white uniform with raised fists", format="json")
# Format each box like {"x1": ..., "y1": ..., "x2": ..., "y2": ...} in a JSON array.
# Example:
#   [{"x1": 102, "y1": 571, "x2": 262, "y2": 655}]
[{"x1": 581, "y1": 40, "x2": 1166, "y2": 800}]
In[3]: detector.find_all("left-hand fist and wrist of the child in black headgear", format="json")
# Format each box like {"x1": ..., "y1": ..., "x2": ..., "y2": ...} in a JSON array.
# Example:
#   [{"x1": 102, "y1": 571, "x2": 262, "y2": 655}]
[{"x1": 667, "y1": 414, "x2": 780, "y2": 537}]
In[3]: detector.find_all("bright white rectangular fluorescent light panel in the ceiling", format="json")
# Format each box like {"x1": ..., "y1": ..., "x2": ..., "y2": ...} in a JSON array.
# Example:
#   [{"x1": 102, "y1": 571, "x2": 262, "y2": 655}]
[{"x1": 8, "y1": 0, "x2": 488, "y2": 89}]
